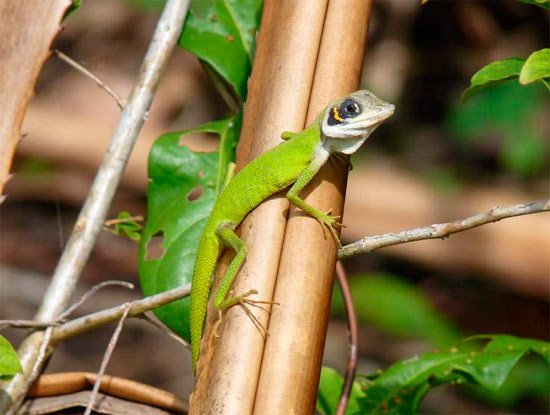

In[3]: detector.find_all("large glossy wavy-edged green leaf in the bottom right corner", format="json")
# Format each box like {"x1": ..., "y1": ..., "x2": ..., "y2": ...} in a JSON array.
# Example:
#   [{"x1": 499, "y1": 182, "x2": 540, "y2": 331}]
[{"x1": 360, "y1": 335, "x2": 550, "y2": 414}]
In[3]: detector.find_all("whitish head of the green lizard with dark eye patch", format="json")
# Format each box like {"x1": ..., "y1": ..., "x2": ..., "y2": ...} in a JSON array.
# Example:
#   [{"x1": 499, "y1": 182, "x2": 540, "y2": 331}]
[{"x1": 321, "y1": 90, "x2": 395, "y2": 154}]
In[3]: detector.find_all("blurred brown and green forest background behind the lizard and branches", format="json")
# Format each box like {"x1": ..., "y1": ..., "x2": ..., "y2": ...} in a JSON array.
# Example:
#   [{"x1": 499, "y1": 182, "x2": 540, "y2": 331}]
[{"x1": 0, "y1": 0, "x2": 550, "y2": 414}]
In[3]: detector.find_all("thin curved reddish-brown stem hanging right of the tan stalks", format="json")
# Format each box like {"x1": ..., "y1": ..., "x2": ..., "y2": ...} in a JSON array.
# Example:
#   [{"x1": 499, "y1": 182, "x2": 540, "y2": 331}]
[{"x1": 336, "y1": 261, "x2": 359, "y2": 415}]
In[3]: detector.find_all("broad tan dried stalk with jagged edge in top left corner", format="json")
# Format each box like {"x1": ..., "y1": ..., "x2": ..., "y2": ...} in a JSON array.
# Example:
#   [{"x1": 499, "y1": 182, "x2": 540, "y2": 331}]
[{"x1": 0, "y1": 0, "x2": 71, "y2": 197}]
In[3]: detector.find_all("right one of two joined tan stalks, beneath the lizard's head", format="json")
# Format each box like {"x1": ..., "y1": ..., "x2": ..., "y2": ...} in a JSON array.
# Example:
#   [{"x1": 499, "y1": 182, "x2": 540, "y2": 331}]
[{"x1": 254, "y1": 0, "x2": 371, "y2": 415}]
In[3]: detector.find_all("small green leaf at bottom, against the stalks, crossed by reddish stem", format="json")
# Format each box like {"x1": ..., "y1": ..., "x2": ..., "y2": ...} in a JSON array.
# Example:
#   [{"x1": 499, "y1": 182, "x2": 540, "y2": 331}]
[{"x1": 317, "y1": 366, "x2": 364, "y2": 415}]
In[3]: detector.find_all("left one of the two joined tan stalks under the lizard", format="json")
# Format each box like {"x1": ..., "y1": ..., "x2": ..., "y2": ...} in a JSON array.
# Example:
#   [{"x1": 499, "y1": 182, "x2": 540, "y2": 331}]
[{"x1": 190, "y1": 0, "x2": 327, "y2": 415}]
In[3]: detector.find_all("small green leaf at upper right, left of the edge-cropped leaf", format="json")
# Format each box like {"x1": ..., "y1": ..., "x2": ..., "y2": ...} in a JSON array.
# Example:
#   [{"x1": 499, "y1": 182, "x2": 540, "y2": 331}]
[{"x1": 461, "y1": 58, "x2": 525, "y2": 102}]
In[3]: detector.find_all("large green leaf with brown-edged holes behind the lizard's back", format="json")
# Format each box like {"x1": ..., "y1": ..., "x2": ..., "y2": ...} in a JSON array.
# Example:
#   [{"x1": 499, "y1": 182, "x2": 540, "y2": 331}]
[{"x1": 139, "y1": 119, "x2": 240, "y2": 340}]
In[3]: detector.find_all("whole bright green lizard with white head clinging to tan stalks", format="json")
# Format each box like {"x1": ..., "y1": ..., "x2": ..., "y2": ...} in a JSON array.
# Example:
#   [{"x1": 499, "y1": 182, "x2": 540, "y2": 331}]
[{"x1": 190, "y1": 91, "x2": 394, "y2": 370}]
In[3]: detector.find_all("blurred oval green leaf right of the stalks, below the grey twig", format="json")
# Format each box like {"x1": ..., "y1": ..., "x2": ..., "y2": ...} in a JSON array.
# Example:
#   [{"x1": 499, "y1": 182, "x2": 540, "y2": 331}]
[{"x1": 334, "y1": 274, "x2": 459, "y2": 346}]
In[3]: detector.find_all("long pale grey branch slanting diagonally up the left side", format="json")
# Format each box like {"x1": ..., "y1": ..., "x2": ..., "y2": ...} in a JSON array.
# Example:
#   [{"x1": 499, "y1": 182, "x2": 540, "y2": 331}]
[{"x1": 0, "y1": 0, "x2": 189, "y2": 413}]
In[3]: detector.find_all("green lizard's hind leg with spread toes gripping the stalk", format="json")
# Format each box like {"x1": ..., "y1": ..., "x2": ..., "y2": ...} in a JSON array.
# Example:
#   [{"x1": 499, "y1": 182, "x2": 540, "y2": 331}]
[{"x1": 214, "y1": 222, "x2": 277, "y2": 335}]
